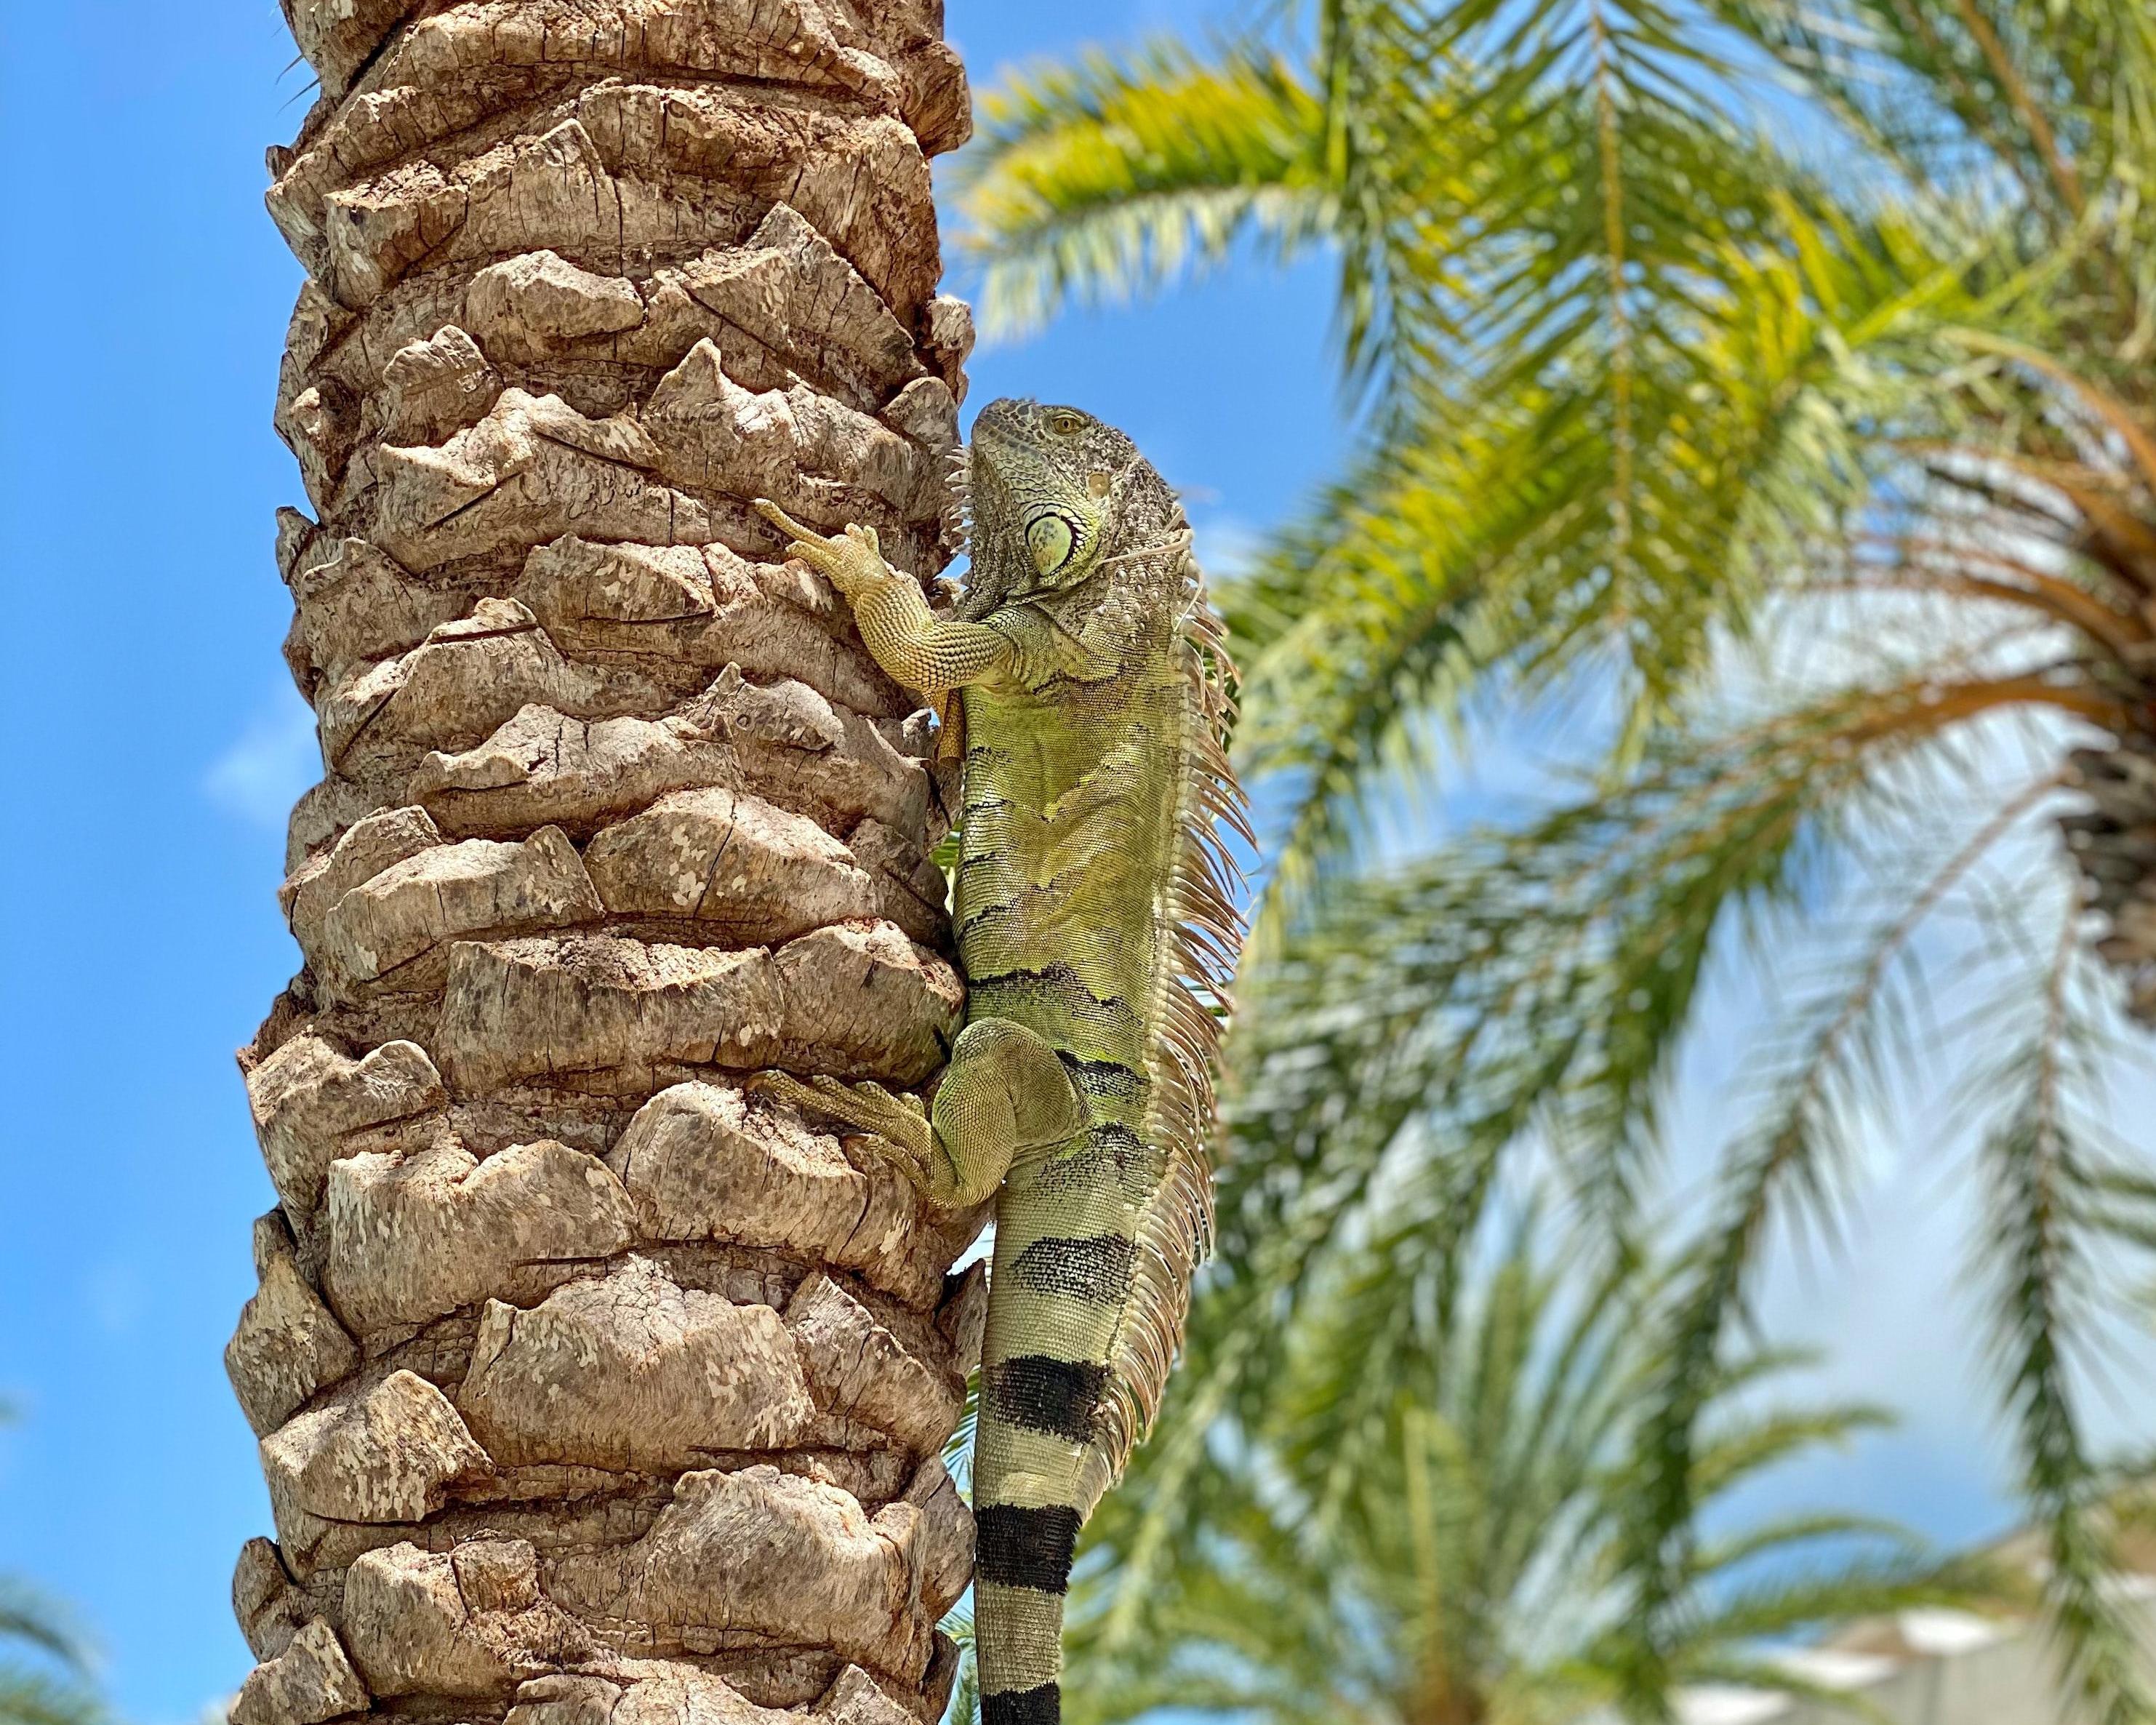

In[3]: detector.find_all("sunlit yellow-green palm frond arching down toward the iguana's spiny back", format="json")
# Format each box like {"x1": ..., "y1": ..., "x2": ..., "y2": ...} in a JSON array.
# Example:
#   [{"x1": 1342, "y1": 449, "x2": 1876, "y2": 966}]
[{"x1": 1225, "y1": 185, "x2": 2000, "y2": 893}]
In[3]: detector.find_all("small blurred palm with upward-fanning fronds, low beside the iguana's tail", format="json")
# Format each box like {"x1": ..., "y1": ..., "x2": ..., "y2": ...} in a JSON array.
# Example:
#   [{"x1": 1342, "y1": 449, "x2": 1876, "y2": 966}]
[{"x1": 951, "y1": 1225, "x2": 1997, "y2": 1725}]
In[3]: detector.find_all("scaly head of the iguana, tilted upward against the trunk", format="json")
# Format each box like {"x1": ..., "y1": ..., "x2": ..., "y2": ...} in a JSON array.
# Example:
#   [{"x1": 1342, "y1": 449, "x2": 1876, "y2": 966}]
[{"x1": 966, "y1": 399, "x2": 1173, "y2": 615}]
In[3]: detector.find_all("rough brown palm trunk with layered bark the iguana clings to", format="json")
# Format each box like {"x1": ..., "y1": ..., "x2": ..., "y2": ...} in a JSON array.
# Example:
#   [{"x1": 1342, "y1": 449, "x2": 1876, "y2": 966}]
[{"x1": 226, "y1": 0, "x2": 981, "y2": 1725}]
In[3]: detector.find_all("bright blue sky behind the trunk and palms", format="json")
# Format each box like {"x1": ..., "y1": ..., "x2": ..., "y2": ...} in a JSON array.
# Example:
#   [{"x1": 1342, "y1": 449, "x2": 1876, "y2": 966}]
[{"x1": 0, "y1": 0, "x2": 2145, "y2": 1725}]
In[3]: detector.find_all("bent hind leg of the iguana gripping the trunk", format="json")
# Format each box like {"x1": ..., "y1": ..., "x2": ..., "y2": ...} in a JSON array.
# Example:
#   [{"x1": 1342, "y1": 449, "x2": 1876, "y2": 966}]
[{"x1": 755, "y1": 1017, "x2": 1086, "y2": 1209}]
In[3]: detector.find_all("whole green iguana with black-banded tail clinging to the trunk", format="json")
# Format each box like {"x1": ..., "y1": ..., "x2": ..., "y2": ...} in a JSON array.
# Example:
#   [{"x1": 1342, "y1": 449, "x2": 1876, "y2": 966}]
[{"x1": 759, "y1": 401, "x2": 1251, "y2": 1725}]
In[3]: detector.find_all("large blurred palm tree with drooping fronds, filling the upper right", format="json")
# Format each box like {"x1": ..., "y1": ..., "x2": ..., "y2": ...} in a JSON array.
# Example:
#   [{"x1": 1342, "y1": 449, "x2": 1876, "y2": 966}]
[{"x1": 961, "y1": 0, "x2": 2156, "y2": 1721}]
